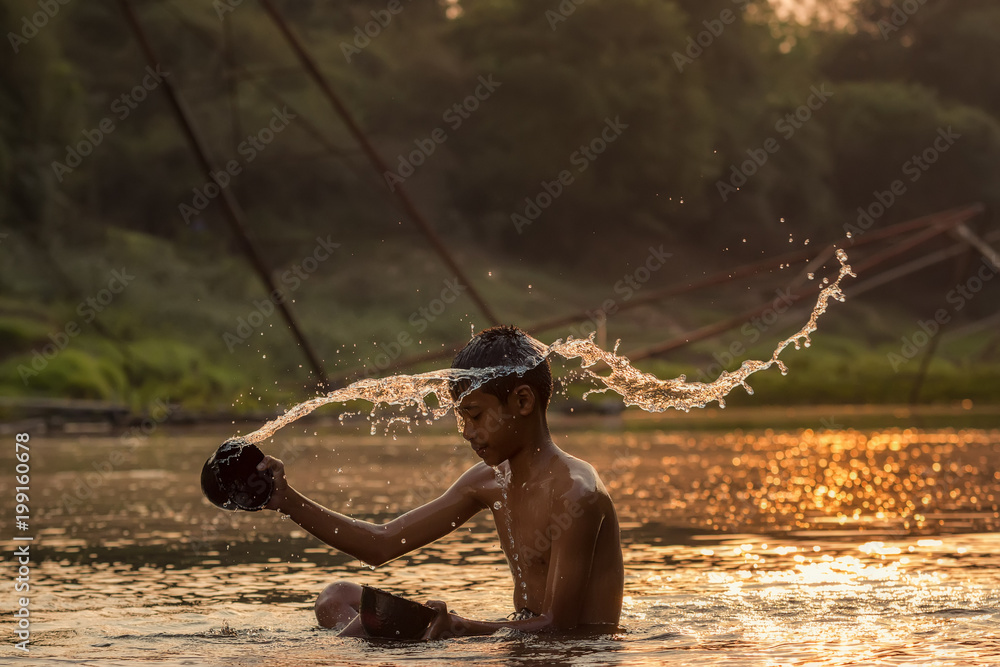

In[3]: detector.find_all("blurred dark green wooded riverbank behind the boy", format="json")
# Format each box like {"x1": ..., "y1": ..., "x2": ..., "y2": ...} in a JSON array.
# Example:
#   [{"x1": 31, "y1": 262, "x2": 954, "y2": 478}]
[{"x1": 0, "y1": 0, "x2": 1000, "y2": 426}]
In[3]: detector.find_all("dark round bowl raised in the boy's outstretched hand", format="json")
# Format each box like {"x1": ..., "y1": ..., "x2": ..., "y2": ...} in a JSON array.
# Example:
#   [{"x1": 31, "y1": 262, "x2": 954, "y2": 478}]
[{"x1": 201, "y1": 438, "x2": 274, "y2": 512}]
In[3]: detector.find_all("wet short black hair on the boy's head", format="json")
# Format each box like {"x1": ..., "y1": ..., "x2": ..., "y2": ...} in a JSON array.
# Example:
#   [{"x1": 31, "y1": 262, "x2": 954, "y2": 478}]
[{"x1": 450, "y1": 324, "x2": 552, "y2": 415}]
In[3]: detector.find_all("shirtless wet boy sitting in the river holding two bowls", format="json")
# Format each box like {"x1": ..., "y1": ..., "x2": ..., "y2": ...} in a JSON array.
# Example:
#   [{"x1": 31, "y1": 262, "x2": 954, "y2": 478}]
[{"x1": 254, "y1": 326, "x2": 624, "y2": 639}]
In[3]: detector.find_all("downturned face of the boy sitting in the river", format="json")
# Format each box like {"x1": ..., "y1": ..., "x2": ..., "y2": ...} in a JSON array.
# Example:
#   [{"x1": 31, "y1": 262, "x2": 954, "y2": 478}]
[{"x1": 457, "y1": 389, "x2": 524, "y2": 466}]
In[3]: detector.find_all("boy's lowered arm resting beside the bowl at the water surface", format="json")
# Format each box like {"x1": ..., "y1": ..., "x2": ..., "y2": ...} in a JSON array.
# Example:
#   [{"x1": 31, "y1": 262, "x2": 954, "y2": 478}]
[{"x1": 424, "y1": 490, "x2": 604, "y2": 639}]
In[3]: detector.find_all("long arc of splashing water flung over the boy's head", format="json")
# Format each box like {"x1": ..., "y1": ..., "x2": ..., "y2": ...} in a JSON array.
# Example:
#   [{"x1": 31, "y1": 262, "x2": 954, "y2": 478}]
[{"x1": 244, "y1": 249, "x2": 855, "y2": 443}]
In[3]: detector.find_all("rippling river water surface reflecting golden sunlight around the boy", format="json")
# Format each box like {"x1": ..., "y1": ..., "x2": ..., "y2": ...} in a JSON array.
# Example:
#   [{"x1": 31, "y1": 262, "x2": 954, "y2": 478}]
[{"x1": 0, "y1": 426, "x2": 1000, "y2": 667}]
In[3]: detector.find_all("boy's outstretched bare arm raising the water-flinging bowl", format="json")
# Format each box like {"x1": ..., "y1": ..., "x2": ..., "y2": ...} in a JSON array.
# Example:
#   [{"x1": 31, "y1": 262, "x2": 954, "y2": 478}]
[{"x1": 258, "y1": 456, "x2": 485, "y2": 566}]
